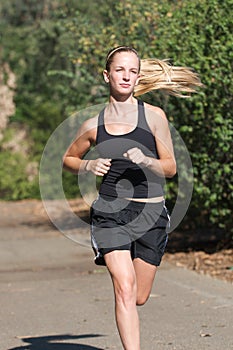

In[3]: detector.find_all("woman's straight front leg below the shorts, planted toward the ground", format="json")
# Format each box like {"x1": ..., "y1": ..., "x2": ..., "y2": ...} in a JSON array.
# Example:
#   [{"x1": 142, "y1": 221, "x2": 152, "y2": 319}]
[{"x1": 105, "y1": 250, "x2": 140, "y2": 350}]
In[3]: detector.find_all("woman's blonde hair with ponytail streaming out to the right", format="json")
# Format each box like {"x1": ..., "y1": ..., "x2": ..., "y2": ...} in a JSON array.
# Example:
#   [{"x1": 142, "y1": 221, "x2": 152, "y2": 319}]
[{"x1": 106, "y1": 46, "x2": 203, "y2": 97}]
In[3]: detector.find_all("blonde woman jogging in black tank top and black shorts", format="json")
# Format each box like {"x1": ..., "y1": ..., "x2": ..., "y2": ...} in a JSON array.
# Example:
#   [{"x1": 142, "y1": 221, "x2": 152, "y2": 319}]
[{"x1": 63, "y1": 46, "x2": 201, "y2": 350}]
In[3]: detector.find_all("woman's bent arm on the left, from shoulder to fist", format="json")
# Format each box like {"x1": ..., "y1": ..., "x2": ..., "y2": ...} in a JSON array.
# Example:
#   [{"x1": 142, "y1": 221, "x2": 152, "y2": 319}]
[{"x1": 63, "y1": 117, "x2": 111, "y2": 176}]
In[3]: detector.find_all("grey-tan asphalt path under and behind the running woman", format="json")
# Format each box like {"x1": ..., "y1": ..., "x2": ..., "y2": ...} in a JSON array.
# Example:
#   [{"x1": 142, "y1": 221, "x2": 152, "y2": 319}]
[{"x1": 0, "y1": 203, "x2": 233, "y2": 350}]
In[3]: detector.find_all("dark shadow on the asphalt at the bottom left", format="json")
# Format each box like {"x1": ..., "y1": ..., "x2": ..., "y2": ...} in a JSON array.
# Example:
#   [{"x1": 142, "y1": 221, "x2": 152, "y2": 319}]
[{"x1": 8, "y1": 334, "x2": 103, "y2": 350}]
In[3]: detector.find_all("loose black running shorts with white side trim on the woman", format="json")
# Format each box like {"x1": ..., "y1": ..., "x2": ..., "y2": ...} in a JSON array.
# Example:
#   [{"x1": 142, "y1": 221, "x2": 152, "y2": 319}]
[{"x1": 90, "y1": 197, "x2": 169, "y2": 266}]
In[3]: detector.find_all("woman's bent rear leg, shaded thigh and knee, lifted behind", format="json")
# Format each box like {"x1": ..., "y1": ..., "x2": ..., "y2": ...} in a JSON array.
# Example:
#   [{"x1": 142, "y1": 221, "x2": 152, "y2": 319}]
[{"x1": 133, "y1": 258, "x2": 156, "y2": 305}]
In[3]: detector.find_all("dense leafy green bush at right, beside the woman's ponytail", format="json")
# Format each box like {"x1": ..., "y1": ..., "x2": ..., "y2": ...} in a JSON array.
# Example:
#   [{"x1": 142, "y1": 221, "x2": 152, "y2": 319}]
[{"x1": 148, "y1": 0, "x2": 233, "y2": 232}]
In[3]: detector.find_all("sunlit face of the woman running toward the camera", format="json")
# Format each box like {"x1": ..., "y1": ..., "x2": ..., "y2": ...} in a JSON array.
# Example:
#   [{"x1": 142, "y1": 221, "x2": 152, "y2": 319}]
[{"x1": 104, "y1": 52, "x2": 139, "y2": 96}]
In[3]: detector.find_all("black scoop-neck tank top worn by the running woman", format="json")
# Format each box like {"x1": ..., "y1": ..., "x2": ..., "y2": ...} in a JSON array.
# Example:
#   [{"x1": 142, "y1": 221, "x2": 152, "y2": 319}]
[{"x1": 96, "y1": 100, "x2": 164, "y2": 198}]
